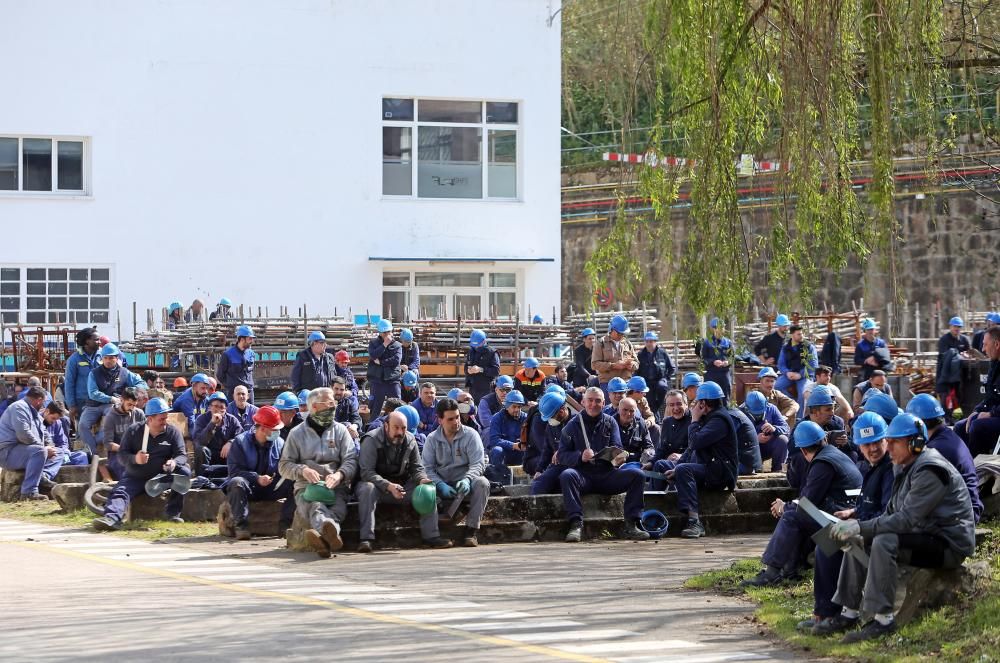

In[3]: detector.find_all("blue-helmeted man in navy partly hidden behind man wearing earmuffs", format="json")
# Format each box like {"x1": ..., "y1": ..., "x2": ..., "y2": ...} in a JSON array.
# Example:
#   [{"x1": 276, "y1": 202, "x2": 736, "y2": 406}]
[{"x1": 796, "y1": 412, "x2": 894, "y2": 635}]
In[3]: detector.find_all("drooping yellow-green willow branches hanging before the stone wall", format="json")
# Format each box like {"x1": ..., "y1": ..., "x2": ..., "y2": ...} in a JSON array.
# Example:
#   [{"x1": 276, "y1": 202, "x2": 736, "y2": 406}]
[{"x1": 586, "y1": 0, "x2": 956, "y2": 313}]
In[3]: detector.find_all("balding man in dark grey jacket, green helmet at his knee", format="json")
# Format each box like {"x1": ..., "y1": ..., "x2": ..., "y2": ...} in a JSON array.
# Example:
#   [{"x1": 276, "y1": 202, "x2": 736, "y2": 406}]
[{"x1": 355, "y1": 410, "x2": 452, "y2": 552}]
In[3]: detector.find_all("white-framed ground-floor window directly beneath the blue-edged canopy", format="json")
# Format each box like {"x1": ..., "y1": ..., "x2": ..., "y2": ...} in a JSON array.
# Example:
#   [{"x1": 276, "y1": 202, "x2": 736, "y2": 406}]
[{"x1": 382, "y1": 269, "x2": 518, "y2": 320}]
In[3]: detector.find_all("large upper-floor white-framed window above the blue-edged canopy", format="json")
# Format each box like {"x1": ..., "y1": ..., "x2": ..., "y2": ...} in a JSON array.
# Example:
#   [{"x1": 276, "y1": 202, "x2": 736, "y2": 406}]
[{"x1": 382, "y1": 97, "x2": 518, "y2": 200}]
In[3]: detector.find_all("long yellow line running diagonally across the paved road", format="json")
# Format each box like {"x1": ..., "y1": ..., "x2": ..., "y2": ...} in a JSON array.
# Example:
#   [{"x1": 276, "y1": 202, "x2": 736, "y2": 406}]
[{"x1": 0, "y1": 541, "x2": 606, "y2": 663}]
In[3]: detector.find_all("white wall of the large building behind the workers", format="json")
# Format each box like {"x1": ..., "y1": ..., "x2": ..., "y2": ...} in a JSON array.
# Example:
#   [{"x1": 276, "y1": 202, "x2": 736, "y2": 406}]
[{"x1": 0, "y1": 0, "x2": 560, "y2": 336}]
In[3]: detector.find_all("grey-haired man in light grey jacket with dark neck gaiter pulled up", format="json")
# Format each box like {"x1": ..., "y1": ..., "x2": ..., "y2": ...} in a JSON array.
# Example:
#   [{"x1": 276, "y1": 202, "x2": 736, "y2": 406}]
[{"x1": 278, "y1": 387, "x2": 358, "y2": 558}]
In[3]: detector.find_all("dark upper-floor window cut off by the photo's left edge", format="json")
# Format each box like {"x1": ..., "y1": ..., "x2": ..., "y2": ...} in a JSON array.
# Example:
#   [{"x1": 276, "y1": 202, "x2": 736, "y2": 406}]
[{"x1": 0, "y1": 134, "x2": 87, "y2": 194}]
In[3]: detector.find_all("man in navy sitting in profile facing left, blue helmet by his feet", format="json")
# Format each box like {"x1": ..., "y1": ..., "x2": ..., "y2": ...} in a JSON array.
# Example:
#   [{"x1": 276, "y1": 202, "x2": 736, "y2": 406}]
[{"x1": 665, "y1": 382, "x2": 739, "y2": 539}]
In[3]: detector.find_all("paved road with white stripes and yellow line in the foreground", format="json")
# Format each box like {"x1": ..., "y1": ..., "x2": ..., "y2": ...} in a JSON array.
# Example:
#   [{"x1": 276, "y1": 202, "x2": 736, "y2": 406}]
[{"x1": 0, "y1": 520, "x2": 793, "y2": 663}]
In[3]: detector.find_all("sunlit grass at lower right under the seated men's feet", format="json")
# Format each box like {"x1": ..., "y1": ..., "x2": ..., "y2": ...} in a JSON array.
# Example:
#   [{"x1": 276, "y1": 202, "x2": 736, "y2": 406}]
[{"x1": 684, "y1": 520, "x2": 1000, "y2": 663}]
